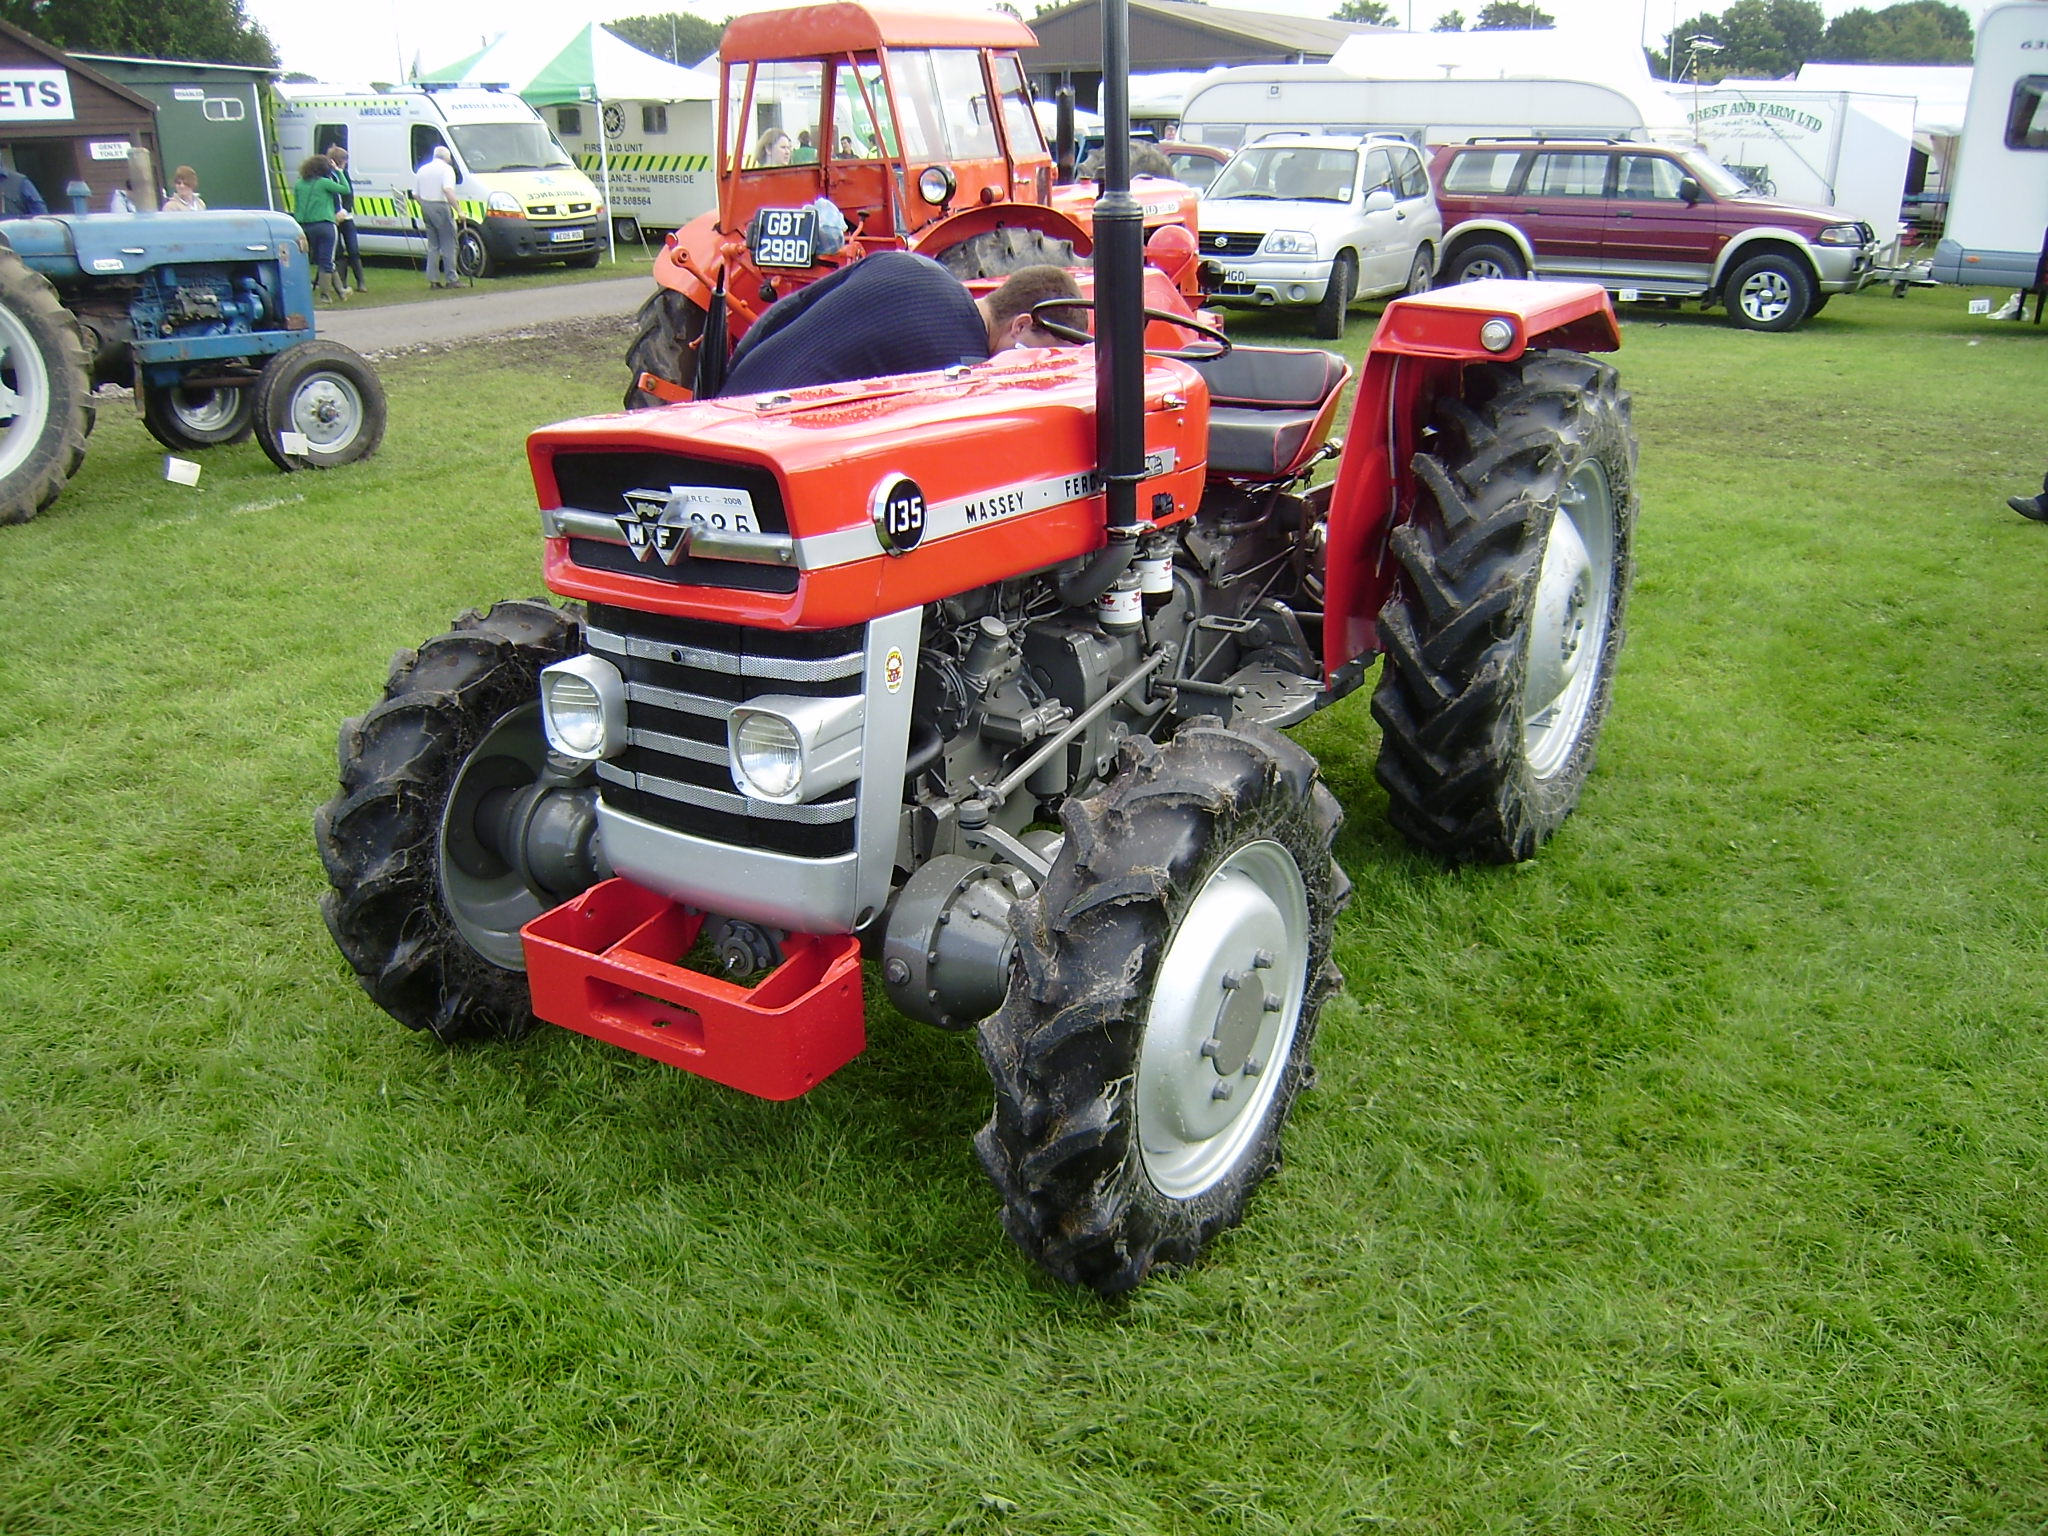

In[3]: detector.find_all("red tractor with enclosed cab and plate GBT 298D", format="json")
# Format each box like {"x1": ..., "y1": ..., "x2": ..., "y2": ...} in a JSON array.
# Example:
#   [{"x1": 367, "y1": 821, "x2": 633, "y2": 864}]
[{"x1": 625, "y1": 0, "x2": 1198, "y2": 410}]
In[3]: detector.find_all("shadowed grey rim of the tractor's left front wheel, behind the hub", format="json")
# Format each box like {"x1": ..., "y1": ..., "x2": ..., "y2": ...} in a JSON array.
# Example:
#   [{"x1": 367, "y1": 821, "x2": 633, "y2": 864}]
[{"x1": 434, "y1": 700, "x2": 547, "y2": 971}]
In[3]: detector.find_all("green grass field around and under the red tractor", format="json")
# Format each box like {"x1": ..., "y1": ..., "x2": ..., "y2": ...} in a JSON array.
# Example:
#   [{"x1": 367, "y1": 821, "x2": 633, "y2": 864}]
[{"x1": 0, "y1": 291, "x2": 2048, "y2": 1536}]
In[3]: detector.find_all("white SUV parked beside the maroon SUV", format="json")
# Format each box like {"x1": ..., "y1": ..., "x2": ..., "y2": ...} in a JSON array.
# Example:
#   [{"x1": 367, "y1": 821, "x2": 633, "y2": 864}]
[{"x1": 1200, "y1": 133, "x2": 1444, "y2": 340}]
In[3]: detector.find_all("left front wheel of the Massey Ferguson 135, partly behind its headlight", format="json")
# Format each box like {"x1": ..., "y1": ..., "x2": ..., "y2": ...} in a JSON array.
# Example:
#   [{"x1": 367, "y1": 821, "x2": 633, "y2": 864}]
[{"x1": 313, "y1": 598, "x2": 590, "y2": 1042}]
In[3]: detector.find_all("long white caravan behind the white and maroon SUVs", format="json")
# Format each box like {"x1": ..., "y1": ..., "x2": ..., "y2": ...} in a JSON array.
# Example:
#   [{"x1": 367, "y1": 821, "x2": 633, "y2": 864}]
[{"x1": 1180, "y1": 63, "x2": 1692, "y2": 150}]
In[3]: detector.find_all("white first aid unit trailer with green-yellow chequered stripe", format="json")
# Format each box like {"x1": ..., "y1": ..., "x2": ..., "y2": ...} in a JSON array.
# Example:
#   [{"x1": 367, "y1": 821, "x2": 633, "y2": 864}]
[{"x1": 541, "y1": 100, "x2": 719, "y2": 244}]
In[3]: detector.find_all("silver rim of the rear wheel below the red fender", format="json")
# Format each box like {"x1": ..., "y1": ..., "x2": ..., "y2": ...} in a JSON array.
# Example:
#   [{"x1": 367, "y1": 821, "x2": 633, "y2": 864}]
[{"x1": 1522, "y1": 459, "x2": 1614, "y2": 778}]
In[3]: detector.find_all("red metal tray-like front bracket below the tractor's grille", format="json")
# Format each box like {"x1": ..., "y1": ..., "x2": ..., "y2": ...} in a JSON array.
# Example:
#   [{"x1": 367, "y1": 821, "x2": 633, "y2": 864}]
[{"x1": 520, "y1": 879, "x2": 868, "y2": 1100}]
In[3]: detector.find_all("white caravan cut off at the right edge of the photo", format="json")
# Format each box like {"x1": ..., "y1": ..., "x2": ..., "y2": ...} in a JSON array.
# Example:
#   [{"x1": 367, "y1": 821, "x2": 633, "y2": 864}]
[{"x1": 1933, "y1": 0, "x2": 2048, "y2": 289}]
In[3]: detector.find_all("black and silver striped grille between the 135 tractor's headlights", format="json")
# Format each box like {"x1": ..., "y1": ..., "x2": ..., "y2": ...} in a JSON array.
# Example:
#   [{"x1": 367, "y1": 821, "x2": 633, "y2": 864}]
[{"x1": 584, "y1": 604, "x2": 866, "y2": 858}]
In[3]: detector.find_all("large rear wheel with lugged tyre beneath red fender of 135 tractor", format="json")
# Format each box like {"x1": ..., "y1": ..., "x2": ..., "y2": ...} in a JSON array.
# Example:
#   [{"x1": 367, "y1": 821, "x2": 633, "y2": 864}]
[{"x1": 1372, "y1": 352, "x2": 1636, "y2": 864}]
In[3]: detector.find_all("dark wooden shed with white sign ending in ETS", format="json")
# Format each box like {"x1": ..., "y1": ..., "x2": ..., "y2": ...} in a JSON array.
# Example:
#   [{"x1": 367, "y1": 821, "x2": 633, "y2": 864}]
[{"x1": 0, "y1": 20, "x2": 158, "y2": 213}]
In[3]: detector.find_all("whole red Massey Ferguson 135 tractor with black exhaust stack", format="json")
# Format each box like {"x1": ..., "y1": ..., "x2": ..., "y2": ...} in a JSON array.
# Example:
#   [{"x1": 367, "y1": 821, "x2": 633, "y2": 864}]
[{"x1": 315, "y1": 87, "x2": 1636, "y2": 1292}]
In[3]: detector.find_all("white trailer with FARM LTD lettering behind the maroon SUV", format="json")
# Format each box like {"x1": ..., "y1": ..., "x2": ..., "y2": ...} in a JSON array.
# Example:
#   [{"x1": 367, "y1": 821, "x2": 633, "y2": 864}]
[{"x1": 1671, "y1": 80, "x2": 1913, "y2": 238}]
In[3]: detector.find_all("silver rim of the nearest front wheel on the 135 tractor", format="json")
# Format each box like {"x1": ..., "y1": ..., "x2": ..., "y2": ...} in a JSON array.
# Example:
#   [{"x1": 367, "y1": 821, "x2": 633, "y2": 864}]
[{"x1": 1137, "y1": 840, "x2": 1309, "y2": 1200}]
